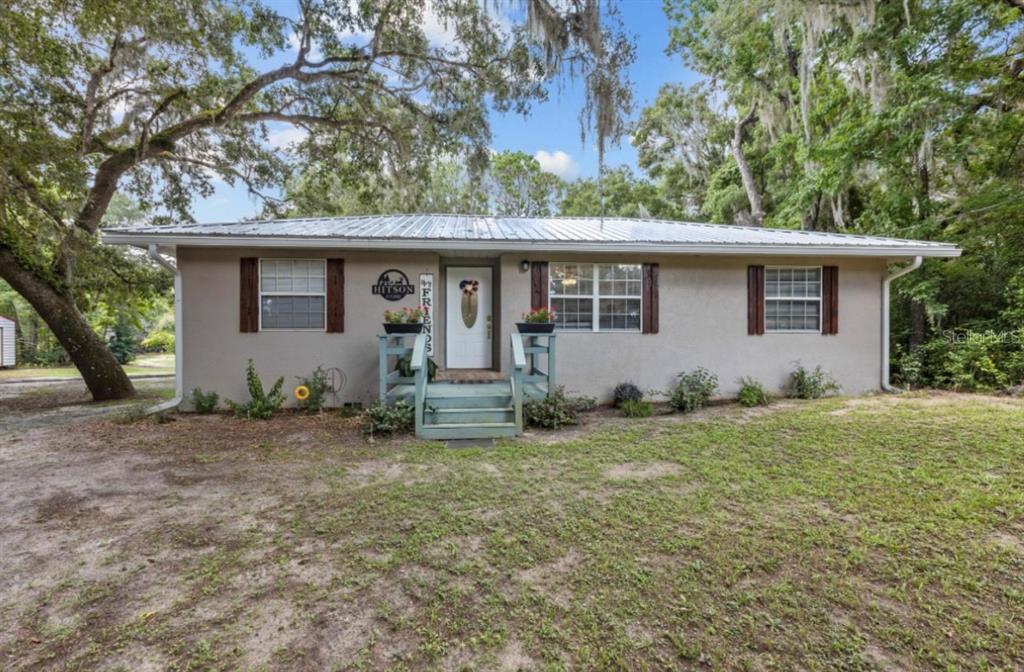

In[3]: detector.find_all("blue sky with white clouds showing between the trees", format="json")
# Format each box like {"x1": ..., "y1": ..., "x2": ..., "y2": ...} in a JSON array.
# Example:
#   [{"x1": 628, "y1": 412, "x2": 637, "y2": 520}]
[{"x1": 193, "y1": 0, "x2": 698, "y2": 222}]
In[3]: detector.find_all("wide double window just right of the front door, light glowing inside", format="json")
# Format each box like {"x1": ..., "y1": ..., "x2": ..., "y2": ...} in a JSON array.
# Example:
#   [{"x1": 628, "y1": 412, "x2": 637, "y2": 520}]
[{"x1": 549, "y1": 263, "x2": 643, "y2": 332}]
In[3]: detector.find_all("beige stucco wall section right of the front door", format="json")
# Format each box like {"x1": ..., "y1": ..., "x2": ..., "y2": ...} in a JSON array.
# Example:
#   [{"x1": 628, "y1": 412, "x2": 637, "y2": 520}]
[{"x1": 502, "y1": 255, "x2": 885, "y2": 400}]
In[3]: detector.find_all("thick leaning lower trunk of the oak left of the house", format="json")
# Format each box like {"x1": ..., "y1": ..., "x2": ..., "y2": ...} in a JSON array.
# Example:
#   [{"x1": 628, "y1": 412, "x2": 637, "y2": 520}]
[{"x1": 0, "y1": 246, "x2": 135, "y2": 402}]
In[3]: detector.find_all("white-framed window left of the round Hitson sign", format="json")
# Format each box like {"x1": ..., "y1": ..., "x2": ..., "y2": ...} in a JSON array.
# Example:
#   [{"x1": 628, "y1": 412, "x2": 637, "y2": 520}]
[{"x1": 259, "y1": 259, "x2": 327, "y2": 330}]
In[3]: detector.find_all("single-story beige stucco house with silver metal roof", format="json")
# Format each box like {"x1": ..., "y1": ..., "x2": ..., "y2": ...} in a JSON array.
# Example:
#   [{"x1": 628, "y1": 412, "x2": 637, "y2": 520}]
[{"x1": 103, "y1": 214, "x2": 959, "y2": 438}]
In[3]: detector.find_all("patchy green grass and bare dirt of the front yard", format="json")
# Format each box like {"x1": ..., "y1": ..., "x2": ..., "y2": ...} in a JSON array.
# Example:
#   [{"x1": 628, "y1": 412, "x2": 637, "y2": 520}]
[{"x1": 0, "y1": 394, "x2": 1024, "y2": 670}]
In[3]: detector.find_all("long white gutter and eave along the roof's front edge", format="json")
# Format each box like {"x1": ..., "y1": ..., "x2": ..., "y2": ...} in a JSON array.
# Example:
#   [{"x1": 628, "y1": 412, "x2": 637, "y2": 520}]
[{"x1": 101, "y1": 232, "x2": 961, "y2": 258}]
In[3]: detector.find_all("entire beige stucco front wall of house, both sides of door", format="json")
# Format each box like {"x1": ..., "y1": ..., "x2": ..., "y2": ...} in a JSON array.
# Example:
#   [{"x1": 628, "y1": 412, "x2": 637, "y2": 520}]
[{"x1": 177, "y1": 248, "x2": 885, "y2": 403}]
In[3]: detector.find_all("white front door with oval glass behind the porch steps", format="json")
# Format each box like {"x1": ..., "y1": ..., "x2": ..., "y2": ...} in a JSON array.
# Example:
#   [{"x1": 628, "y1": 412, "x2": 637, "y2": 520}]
[{"x1": 444, "y1": 266, "x2": 494, "y2": 369}]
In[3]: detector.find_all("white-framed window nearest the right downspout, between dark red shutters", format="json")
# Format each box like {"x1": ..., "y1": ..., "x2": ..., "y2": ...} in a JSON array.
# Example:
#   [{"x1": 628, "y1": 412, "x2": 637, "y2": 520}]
[{"x1": 765, "y1": 266, "x2": 821, "y2": 332}]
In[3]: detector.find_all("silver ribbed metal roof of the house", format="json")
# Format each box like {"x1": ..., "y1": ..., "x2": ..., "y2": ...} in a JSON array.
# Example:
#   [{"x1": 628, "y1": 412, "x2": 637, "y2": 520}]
[{"x1": 102, "y1": 214, "x2": 959, "y2": 257}]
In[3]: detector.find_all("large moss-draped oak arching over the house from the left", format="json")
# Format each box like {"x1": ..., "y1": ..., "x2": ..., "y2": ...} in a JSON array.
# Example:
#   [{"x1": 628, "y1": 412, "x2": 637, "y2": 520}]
[{"x1": 0, "y1": 0, "x2": 632, "y2": 400}]
